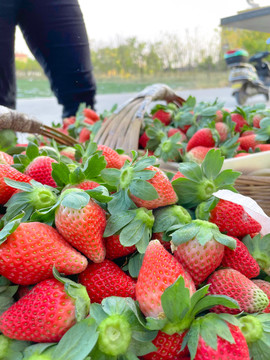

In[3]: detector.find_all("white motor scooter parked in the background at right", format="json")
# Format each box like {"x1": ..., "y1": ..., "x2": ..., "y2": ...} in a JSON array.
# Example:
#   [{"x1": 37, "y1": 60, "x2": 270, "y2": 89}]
[{"x1": 224, "y1": 49, "x2": 269, "y2": 105}]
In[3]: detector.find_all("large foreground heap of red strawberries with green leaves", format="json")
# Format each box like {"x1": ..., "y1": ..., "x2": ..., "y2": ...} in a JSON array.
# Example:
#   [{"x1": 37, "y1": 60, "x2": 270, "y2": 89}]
[{"x1": 0, "y1": 105, "x2": 270, "y2": 360}]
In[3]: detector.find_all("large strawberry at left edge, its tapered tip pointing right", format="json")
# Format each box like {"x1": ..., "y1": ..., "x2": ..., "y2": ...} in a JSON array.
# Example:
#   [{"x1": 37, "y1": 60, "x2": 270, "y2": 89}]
[{"x1": 0, "y1": 222, "x2": 87, "y2": 285}]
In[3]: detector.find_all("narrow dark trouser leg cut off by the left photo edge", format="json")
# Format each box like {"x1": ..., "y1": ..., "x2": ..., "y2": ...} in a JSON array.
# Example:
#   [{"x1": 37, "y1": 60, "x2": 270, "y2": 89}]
[{"x1": 0, "y1": 0, "x2": 21, "y2": 109}]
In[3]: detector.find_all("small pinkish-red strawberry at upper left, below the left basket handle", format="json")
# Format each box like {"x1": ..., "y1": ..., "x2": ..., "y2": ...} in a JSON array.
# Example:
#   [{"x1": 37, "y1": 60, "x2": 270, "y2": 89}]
[{"x1": 24, "y1": 156, "x2": 57, "y2": 187}]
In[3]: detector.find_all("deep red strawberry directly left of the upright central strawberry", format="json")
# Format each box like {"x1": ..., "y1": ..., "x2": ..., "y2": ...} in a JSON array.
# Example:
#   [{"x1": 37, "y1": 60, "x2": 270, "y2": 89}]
[{"x1": 79, "y1": 259, "x2": 136, "y2": 303}]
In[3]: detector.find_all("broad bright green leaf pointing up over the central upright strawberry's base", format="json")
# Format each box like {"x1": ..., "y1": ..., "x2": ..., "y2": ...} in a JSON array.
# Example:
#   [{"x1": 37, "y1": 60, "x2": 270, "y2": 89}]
[{"x1": 161, "y1": 276, "x2": 190, "y2": 323}]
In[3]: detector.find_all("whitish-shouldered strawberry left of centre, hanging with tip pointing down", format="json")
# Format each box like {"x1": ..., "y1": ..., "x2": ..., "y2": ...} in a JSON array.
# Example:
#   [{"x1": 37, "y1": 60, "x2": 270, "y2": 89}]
[{"x1": 55, "y1": 189, "x2": 106, "y2": 262}]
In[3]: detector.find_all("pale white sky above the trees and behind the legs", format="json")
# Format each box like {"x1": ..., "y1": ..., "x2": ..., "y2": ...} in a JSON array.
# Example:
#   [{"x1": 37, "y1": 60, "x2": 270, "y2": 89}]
[{"x1": 15, "y1": 0, "x2": 270, "y2": 55}]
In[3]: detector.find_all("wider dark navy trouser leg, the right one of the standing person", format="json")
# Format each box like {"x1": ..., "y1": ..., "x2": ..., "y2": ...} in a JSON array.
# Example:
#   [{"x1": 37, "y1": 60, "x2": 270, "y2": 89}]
[{"x1": 19, "y1": 0, "x2": 96, "y2": 117}]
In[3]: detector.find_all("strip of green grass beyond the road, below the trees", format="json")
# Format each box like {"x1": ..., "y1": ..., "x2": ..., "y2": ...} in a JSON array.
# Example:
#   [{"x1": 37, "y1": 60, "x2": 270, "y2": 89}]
[{"x1": 17, "y1": 71, "x2": 228, "y2": 99}]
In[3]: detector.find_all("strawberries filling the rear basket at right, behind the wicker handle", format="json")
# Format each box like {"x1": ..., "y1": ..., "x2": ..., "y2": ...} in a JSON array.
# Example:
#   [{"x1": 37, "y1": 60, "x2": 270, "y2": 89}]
[{"x1": 139, "y1": 96, "x2": 270, "y2": 163}]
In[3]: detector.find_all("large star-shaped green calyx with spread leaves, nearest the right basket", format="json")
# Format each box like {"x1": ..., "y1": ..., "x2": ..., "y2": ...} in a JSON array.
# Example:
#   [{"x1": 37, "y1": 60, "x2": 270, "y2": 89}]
[{"x1": 172, "y1": 149, "x2": 240, "y2": 208}]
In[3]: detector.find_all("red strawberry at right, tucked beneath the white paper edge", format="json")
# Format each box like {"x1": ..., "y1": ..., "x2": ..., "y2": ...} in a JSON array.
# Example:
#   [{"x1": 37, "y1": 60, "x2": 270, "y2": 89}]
[{"x1": 209, "y1": 200, "x2": 262, "y2": 238}]
